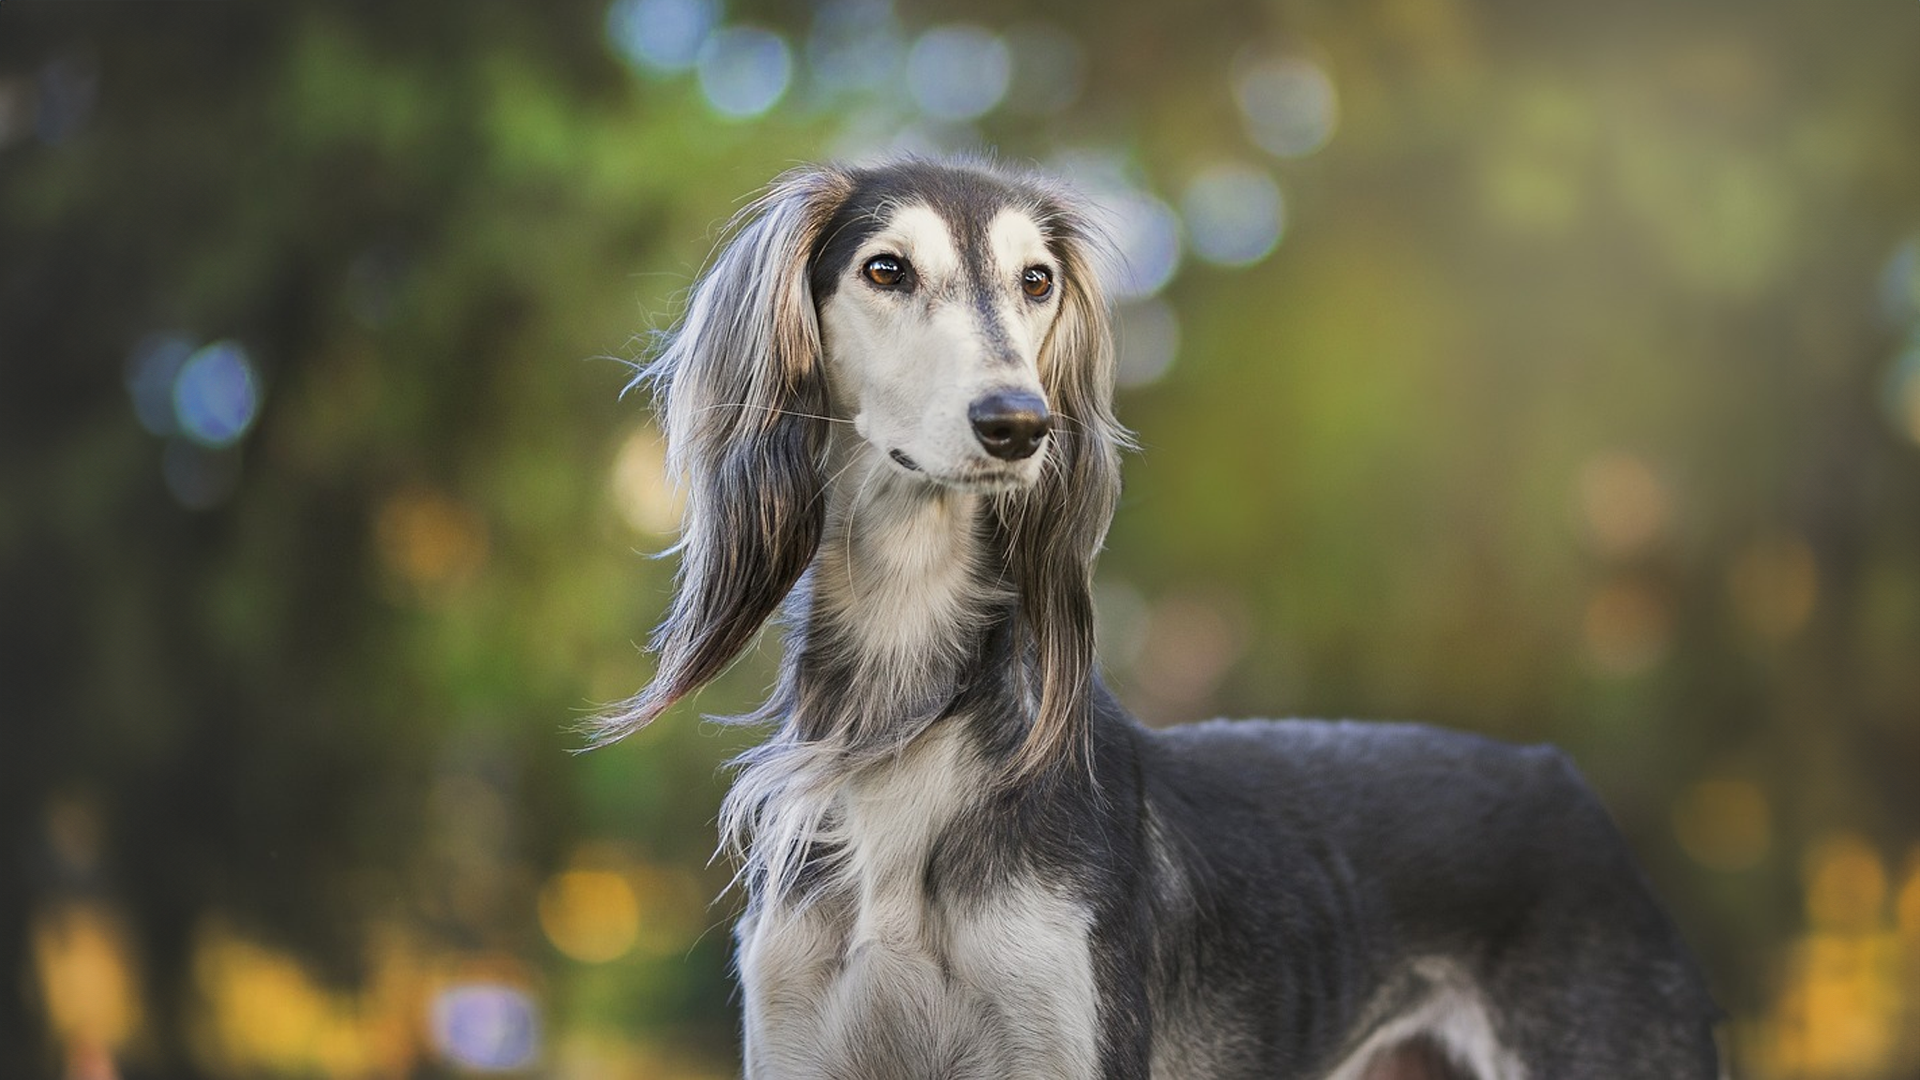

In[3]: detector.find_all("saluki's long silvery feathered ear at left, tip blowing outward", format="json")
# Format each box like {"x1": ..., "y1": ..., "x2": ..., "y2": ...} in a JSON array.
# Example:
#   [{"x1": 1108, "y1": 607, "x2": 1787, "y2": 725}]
[{"x1": 591, "y1": 169, "x2": 851, "y2": 744}]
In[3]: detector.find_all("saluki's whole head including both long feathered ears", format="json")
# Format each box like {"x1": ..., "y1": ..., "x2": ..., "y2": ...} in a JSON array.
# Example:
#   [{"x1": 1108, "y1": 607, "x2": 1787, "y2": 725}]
[{"x1": 599, "y1": 160, "x2": 1125, "y2": 761}]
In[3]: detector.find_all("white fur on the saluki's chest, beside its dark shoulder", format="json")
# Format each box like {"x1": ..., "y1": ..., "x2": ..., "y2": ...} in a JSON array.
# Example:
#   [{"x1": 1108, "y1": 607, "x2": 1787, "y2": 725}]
[{"x1": 739, "y1": 723, "x2": 1098, "y2": 1080}]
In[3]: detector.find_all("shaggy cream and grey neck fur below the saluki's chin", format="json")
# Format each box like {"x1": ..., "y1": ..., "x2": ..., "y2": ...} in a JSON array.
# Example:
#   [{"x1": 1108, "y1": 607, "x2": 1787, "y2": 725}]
[{"x1": 720, "y1": 438, "x2": 1037, "y2": 896}]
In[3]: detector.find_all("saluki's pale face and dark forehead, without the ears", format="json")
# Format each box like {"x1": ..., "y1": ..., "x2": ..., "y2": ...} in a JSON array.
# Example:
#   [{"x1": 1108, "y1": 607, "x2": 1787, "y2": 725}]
[{"x1": 808, "y1": 165, "x2": 1089, "y2": 492}]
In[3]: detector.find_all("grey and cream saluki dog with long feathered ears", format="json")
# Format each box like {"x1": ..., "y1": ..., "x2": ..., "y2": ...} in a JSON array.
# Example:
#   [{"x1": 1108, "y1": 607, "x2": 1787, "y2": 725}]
[{"x1": 597, "y1": 160, "x2": 1716, "y2": 1080}]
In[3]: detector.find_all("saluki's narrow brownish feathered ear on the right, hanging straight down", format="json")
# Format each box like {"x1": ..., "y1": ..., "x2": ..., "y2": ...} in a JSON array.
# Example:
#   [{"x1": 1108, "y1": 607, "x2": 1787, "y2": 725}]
[{"x1": 1000, "y1": 202, "x2": 1133, "y2": 778}]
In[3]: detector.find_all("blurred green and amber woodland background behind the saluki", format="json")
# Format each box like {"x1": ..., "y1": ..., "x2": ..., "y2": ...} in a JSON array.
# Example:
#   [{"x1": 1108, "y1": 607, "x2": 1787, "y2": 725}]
[{"x1": 0, "y1": 0, "x2": 1920, "y2": 1080}]
